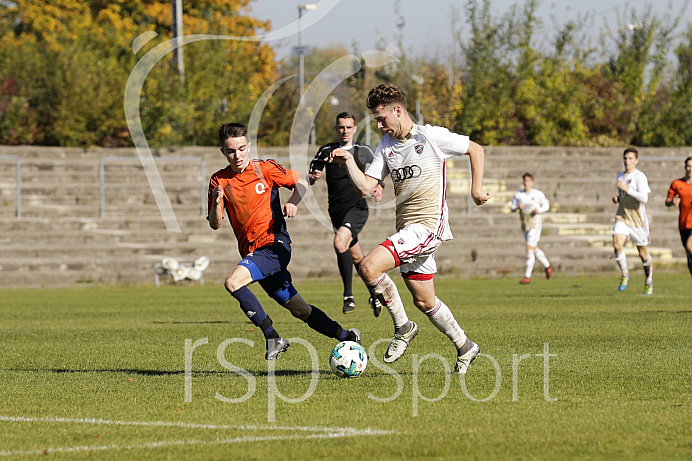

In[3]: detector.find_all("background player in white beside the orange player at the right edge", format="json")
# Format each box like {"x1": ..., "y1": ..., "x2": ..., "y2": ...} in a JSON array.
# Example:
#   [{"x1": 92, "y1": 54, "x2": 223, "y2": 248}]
[{"x1": 613, "y1": 147, "x2": 654, "y2": 295}]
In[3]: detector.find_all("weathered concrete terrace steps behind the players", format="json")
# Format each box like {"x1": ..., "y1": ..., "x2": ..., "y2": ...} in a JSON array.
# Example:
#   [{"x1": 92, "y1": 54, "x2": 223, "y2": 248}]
[{"x1": 0, "y1": 146, "x2": 687, "y2": 286}]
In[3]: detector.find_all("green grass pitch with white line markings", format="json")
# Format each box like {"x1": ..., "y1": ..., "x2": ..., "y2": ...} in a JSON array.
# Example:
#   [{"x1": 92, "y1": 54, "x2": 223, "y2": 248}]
[{"x1": 0, "y1": 274, "x2": 692, "y2": 460}]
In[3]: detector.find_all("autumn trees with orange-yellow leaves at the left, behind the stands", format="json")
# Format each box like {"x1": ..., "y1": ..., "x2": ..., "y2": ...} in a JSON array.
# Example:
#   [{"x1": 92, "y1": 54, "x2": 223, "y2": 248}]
[{"x1": 0, "y1": 0, "x2": 276, "y2": 146}]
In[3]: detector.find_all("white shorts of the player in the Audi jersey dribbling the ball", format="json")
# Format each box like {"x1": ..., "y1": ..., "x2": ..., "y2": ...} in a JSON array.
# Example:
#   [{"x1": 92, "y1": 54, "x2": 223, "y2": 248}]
[{"x1": 382, "y1": 224, "x2": 442, "y2": 274}]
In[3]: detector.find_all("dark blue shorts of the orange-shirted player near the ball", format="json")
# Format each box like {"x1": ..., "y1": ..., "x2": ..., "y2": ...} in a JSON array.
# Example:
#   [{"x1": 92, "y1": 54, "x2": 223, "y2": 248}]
[{"x1": 238, "y1": 242, "x2": 296, "y2": 304}]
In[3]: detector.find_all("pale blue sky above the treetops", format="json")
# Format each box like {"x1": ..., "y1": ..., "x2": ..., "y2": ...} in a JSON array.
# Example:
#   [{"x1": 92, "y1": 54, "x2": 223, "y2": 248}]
[{"x1": 250, "y1": 0, "x2": 692, "y2": 59}]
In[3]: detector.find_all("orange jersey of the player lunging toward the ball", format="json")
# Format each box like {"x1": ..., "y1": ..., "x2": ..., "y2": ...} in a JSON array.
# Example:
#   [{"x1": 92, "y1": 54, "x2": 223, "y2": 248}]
[{"x1": 207, "y1": 160, "x2": 300, "y2": 257}]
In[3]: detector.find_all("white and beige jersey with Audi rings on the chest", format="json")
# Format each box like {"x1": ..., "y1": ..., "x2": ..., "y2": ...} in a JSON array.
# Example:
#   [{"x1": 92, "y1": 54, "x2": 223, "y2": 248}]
[{"x1": 365, "y1": 125, "x2": 470, "y2": 240}]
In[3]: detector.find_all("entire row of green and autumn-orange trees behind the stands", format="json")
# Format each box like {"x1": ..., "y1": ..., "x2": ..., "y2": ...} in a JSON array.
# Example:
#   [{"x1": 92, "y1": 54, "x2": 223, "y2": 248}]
[{"x1": 0, "y1": 0, "x2": 692, "y2": 146}]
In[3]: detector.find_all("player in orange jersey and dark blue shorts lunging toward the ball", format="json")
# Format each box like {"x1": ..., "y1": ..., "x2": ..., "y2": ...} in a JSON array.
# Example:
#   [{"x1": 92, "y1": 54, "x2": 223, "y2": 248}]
[{"x1": 208, "y1": 123, "x2": 360, "y2": 360}]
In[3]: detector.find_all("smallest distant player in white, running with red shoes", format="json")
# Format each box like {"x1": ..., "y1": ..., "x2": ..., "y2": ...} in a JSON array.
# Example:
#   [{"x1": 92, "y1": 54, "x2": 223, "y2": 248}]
[{"x1": 509, "y1": 173, "x2": 553, "y2": 285}]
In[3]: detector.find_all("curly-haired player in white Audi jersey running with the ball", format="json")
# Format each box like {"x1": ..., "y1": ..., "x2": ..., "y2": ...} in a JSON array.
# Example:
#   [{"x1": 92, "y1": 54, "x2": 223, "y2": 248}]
[{"x1": 331, "y1": 84, "x2": 490, "y2": 374}]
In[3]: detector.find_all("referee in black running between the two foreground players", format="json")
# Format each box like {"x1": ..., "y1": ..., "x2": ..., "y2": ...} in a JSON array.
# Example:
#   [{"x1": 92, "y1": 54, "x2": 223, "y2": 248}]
[{"x1": 308, "y1": 112, "x2": 384, "y2": 317}]
